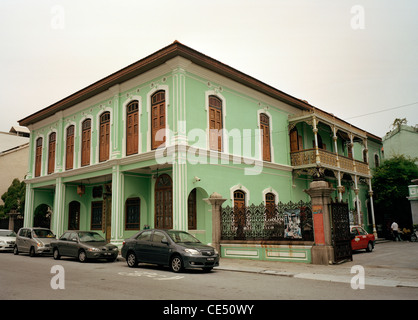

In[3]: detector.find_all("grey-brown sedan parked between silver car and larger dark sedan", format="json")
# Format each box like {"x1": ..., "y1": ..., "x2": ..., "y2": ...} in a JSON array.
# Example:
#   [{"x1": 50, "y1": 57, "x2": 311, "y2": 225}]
[{"x1": 51, "y1": 230, "x2": 119, "y2": 262}]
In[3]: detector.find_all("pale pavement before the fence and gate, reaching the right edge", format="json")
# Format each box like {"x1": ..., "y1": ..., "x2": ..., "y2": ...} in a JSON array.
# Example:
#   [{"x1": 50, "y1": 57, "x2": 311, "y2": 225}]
[{"x1": 216, "y1": 241, "x2": 418, "y2": 288}]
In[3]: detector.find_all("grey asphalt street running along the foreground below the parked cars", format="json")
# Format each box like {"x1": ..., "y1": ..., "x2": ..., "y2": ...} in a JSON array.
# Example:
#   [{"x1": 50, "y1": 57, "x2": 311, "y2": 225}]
[{"x1": 0, "y1": 244, "x2": 418, "y2": 301}]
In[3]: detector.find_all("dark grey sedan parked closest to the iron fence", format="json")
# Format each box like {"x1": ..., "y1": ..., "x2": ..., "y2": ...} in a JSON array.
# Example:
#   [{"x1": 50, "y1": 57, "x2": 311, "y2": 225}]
[{"x1": 121, "y1": 229, "x2": 219, "y2": 272}]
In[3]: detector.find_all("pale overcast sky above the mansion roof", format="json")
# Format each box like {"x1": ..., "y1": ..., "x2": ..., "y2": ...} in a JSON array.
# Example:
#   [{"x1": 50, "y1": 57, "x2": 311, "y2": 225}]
[{"x1": 0, "y1": 0, "x2": 418, "y2": 137}]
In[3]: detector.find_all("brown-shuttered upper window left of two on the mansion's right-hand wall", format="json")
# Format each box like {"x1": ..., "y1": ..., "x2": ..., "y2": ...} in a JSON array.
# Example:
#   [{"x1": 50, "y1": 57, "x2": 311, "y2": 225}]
[{"x1": 209, "y1": 96, "x2": 223, "y2": 151}]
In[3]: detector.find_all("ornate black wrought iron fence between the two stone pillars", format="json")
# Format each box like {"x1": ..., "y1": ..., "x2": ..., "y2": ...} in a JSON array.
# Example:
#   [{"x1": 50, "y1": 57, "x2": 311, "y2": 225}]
[{"x1": 221, "y1": 201, "x2": 313, "y2": 241}]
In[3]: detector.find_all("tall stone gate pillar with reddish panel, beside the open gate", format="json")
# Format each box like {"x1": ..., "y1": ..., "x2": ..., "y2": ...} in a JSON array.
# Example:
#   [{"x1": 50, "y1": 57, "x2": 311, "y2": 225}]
[{"x1": 304, "y1": 180, "x2": 335, "y2": 265}]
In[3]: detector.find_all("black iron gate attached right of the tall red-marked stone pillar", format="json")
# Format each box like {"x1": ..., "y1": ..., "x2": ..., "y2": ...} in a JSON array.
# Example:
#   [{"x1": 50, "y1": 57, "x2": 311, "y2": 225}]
[{"x1": 331, "y1": 202, "x2": 353, "y2": 262}]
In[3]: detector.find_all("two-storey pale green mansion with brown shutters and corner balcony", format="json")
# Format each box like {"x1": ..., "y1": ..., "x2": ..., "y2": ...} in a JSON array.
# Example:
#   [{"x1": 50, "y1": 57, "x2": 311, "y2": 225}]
[{"x1": 19, "y1": 41, "x2": 382, "y2": 251}]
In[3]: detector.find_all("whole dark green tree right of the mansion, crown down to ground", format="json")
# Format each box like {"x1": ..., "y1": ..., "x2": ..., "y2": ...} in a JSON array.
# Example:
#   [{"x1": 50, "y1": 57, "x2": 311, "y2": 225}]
[{"x1": 372, "y1": 155, "x2": 418, "y2": 238}]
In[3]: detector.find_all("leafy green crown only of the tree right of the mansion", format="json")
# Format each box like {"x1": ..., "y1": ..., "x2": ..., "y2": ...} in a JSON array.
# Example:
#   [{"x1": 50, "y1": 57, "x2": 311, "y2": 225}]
[{"x1": 372, "y1": 155, "x2": 418, "y2": 207}]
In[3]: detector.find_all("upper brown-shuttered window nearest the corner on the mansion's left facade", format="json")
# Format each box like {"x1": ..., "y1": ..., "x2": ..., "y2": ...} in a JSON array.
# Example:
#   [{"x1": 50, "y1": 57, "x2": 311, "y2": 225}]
[{"x1": 151, "y1": 90, "x2": 166, "y2": 150}]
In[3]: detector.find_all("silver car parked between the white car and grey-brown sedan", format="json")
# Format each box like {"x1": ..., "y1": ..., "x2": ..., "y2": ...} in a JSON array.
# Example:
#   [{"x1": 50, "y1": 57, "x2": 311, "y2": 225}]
[{"x1": 13, "y1": 227, "x2": 55, "y2": 257}]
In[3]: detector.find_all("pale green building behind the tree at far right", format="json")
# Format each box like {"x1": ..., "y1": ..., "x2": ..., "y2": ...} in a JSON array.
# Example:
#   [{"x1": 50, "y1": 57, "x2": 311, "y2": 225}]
[{"x1": 383, "y1": 125, "x2": 418, "y2": 163}]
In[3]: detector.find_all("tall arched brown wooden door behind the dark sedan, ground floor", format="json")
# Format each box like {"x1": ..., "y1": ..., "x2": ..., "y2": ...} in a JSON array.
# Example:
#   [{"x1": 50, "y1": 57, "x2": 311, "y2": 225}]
[{"x1": 154, "y1": 174, "x2": 173, "y2": 229}]
